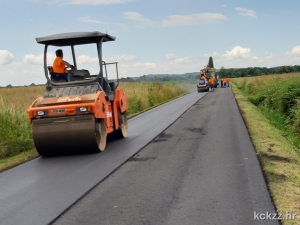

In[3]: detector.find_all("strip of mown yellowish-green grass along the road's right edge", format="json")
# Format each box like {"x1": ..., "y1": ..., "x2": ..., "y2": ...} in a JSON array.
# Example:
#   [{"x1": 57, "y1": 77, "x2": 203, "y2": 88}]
[{"x1": 231, "y1": 83, "x2": 300, "y2": 225}]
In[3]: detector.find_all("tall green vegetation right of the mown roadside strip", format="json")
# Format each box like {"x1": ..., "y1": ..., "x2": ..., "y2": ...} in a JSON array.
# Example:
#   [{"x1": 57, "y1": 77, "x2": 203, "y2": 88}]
[{"x1": 232, "y1": 73, "x2": 300, "y2": 149}]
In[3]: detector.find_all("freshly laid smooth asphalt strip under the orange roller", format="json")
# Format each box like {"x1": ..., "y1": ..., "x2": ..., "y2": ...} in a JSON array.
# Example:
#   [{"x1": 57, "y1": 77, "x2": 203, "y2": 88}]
[{"x1": 0, "y1": 92, "x2": 205, "y2": 225}]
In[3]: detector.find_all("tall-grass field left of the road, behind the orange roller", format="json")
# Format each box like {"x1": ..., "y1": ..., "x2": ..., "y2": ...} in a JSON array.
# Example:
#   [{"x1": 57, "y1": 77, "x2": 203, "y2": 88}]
[{"x1": 0, "y1": 83, "x2": 188, "y2": 163}]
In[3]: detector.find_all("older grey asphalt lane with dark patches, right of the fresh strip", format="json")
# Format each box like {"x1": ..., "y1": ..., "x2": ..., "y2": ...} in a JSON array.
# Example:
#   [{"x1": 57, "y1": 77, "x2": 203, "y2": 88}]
[{"x1": 54, "y1": 88, "x2": 279, "y2": 225}]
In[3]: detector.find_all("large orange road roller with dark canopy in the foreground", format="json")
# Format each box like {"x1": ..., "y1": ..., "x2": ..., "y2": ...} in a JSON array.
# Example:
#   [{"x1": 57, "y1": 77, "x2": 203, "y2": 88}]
[{"x1": 28, "y1": 31, "x2": 128, "y2": 156}]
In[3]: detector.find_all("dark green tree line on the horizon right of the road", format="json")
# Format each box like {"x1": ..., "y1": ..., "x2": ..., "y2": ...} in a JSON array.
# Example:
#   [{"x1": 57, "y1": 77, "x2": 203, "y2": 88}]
[{"x1": 218, "y1": 65, "x2": 300, "y2": 78}]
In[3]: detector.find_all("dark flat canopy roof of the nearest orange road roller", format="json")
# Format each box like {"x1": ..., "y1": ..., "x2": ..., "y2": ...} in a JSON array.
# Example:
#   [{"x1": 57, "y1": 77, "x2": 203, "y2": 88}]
[{"x1": 36, "y1": 31, "x2": 116, "y2": 46}]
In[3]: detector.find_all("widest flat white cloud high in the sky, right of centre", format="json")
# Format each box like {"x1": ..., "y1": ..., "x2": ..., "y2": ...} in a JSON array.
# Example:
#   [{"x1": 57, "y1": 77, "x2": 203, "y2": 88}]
[{"x1": 162, "y1": 13, "x2": 227, "y2": 27}]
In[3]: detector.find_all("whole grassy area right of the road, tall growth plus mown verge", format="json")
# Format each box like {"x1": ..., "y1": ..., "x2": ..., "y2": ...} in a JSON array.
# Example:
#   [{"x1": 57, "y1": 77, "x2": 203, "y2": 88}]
[{"x1": 232, "y1": 73, "x2": 300, "y2": 225}]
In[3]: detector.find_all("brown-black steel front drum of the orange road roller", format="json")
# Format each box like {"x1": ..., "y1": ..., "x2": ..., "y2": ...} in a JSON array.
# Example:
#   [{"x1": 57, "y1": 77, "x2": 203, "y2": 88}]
[{"x1": 32, "y1": 115, "x2": 106, "y2": 156}]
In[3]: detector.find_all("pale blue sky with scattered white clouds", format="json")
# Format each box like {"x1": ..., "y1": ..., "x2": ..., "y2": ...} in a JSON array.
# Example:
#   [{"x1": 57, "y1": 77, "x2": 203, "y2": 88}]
[{"x1": 0, "y1": 0, "x2": 300, "y2": 86}]
